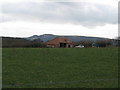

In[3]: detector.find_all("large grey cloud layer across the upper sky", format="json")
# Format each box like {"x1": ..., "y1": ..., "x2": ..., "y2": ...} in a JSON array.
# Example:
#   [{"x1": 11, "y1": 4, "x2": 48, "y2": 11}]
[{"x1": 2, "y1": 2, "x2": 117, "y2": 27}]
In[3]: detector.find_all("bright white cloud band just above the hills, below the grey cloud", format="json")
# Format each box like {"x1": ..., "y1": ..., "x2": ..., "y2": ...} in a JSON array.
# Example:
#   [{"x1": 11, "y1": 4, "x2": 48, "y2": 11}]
[{"x1": 0, "y1": 21, "x2": 118, "y2": 38}]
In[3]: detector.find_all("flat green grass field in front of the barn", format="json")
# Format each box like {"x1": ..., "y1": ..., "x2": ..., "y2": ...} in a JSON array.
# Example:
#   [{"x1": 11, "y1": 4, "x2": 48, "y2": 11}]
[{"x1": 2, "y1": 48, "x2": 118, "y2": 88}]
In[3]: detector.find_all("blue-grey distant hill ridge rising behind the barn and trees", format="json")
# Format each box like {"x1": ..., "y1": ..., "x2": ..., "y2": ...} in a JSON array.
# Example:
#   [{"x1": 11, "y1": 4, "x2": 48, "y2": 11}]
[{"x1": 26, "y1": 34, "x2": 108, "y2": 42}]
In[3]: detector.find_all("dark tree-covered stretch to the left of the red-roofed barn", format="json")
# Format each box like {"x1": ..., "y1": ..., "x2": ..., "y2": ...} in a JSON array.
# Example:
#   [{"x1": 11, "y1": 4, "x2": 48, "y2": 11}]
[{"x1": 2, "y1": 37, "x2": 46, "y2": 48}]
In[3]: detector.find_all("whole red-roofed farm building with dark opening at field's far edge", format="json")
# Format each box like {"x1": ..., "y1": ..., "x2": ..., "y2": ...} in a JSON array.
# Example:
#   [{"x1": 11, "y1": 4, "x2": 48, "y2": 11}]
[{"x1": 47, "y1": 37, "x2": 73, "y2": 48}]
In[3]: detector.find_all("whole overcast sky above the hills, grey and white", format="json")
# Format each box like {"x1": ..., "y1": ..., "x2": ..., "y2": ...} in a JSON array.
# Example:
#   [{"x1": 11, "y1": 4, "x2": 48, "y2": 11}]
[{"x1": 0, "y1": 0, "x2": 119, "y2": 38}]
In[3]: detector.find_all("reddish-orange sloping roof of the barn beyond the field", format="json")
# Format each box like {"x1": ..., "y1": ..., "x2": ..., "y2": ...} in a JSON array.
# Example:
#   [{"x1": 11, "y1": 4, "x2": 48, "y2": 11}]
[{"x1": 47, "y1": 37, "x2": 72, "y2": 45}]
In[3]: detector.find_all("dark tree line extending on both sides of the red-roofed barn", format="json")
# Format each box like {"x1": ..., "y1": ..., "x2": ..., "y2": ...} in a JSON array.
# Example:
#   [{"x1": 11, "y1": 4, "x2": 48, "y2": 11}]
[{"x1": 2, "y1": 37, "x2": 120, "y2": 48}]
